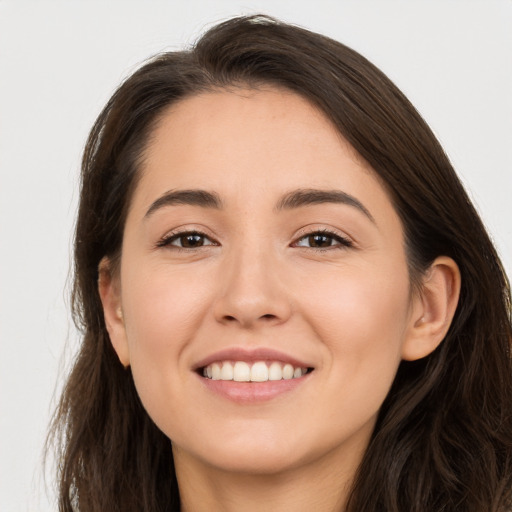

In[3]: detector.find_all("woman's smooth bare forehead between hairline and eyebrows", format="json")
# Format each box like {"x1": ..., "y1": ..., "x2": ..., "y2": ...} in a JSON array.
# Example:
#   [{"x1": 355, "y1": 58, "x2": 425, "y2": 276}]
[{"x1": 134, "y1": 88, "x2": 396, "y2": 224}]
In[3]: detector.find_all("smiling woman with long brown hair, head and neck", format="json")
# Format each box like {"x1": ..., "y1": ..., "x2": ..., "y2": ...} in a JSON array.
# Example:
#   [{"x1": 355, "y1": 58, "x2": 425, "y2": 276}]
[{"x1": 49, "y1": 16, "x2": 512, "y2": 512}]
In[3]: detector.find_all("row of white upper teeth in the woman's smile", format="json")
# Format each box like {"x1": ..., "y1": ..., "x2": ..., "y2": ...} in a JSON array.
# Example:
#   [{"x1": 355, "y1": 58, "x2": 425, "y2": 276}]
[{"x1": 203, "y1": 361, "x2": 307, "y2": 382}]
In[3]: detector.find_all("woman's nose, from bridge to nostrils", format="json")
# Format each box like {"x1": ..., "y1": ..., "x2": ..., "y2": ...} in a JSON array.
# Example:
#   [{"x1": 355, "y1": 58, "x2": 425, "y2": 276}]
[{"x1": 214, "y1": 243, "x2": 292, "y2": 329}]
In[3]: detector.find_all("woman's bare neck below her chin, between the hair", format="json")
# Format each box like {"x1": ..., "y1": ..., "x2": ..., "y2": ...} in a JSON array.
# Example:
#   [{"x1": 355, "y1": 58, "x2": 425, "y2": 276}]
[{"x1": 174, "y1": 442, "x2": 362, "y2": 512}]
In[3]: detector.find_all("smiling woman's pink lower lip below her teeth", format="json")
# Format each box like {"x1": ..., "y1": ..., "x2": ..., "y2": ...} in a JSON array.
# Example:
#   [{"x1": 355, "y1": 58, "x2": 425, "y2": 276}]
[{"x1": 198, "y1": 373, "x2": 311, "y2": 404}]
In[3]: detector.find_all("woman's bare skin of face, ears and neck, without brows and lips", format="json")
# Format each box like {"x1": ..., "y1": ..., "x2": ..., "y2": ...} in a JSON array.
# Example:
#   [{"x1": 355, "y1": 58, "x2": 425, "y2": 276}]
[{"x1": 100, "y1": 89, "x2": 460, "y2": 511}]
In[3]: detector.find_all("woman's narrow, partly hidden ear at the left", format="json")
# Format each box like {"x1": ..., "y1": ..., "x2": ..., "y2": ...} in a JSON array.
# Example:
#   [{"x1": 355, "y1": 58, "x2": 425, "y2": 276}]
[{"x1": 98, "y1": 257, "x2": 130, "y2": 368}]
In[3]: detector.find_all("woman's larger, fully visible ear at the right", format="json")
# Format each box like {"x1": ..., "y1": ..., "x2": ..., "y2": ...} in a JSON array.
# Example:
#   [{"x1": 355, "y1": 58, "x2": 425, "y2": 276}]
[{"x1": 402, "y1": 256, "x2": 460, "y2": 361}]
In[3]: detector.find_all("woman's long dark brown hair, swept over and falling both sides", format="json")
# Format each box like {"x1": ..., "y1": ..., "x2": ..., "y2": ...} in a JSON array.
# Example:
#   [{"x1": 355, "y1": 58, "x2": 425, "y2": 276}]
[{"x1": 53, "y1": 16, "x2": 512, "y2": 512}]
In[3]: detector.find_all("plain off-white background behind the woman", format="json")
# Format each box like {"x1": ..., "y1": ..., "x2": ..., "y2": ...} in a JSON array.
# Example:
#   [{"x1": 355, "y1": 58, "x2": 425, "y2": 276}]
[{"x1": 0, "y1": 0, "x2": 512, "y2": 512}]
